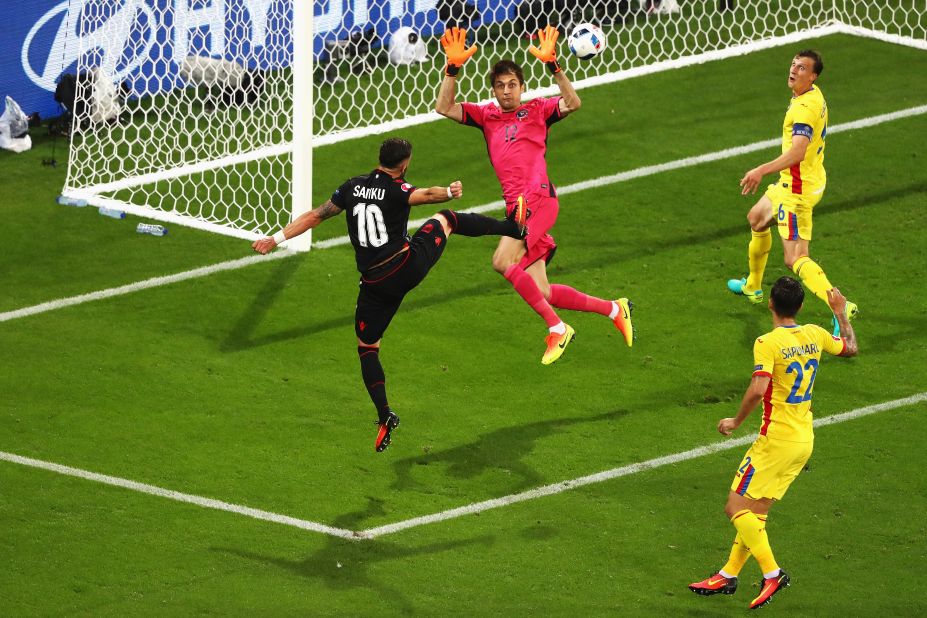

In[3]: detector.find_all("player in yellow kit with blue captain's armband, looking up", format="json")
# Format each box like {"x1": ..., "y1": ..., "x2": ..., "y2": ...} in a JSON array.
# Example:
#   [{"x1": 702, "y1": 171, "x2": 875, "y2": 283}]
[{"x1": 727, "y1": 49, "x2": 858, "y2": 334}]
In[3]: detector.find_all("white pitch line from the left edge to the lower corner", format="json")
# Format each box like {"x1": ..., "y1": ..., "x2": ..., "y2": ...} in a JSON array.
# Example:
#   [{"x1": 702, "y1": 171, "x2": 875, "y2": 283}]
[{"x1": 0, "y1": 451, "x2": 357, "y2": 539}]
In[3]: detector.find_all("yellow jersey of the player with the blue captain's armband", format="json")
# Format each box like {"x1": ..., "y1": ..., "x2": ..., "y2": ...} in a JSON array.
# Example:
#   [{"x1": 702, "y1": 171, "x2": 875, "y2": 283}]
[{"x1": 779, "y1": 86, "x2": 827, "y2": 195}]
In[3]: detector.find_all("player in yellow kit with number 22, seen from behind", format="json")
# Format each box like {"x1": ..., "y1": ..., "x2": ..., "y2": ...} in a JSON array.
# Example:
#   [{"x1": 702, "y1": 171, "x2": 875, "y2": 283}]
[{"x1": 689, "y1": 277, "x2": 857, "y2": 609}]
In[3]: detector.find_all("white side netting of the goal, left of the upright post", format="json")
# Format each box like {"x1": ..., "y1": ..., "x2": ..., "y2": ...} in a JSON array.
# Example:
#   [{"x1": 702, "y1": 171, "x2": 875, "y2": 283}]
[{"x1": 66, "y1": 0, "x2": 293, "y2": 233}]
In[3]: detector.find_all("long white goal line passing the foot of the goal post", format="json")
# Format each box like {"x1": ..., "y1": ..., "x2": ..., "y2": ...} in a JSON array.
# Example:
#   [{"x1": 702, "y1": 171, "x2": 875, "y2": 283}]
[{"x1": 0, "y1": 105, "x2": 927, "y2": 322}]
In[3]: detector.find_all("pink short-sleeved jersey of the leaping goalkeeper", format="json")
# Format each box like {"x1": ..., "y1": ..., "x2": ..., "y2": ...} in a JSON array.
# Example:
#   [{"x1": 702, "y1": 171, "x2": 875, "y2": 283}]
[{"x1": 460, "y1": 97, "x2": 563, "y2": 204}]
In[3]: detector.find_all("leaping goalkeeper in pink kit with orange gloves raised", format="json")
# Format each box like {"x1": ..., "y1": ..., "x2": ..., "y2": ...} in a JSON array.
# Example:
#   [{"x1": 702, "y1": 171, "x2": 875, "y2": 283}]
[{"x1": 435, "y1": 26, "x2": 634, "y2": 365}]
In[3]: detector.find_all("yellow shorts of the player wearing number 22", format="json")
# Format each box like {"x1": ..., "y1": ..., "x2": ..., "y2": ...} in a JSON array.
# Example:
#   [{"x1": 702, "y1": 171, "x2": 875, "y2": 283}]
[{"x1": 731, "y1": 436, "x2": 814, "y2": 500}]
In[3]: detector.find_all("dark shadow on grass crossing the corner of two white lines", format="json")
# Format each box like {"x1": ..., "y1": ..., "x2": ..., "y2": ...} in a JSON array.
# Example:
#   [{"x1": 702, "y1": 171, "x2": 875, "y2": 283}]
[{"x1": 212, "y1": 497, "x2": 495, "y2": 614}]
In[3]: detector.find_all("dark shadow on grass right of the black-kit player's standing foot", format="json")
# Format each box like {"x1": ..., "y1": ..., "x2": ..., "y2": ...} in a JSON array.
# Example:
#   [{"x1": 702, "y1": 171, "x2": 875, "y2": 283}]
[{"x1": 393, "y1": 410, "x2": 630, "y2": 492}]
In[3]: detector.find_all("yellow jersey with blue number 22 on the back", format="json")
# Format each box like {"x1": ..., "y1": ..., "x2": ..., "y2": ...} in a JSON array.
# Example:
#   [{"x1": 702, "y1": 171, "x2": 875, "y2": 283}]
[{"x1": 753, "y1": 324, "x2": 845, "y2": 442}]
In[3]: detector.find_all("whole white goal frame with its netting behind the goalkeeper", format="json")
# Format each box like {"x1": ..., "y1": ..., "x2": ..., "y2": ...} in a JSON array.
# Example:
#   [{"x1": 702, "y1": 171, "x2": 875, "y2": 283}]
[{"x1": 61, "y1": 0, "x2": 927, "y2": 245}]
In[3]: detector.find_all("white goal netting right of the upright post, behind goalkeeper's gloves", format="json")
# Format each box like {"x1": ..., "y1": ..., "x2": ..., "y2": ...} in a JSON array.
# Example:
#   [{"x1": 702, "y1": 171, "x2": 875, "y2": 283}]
[{"x1": 314, "y1": 0, "x2": 833, "y2": 136}]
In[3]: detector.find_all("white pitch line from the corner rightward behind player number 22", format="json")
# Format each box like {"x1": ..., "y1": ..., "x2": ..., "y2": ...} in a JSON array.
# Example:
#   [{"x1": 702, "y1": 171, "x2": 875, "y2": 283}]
[{"x1": 357, "y1": 392, "x2": 927, "y2": 539}]
